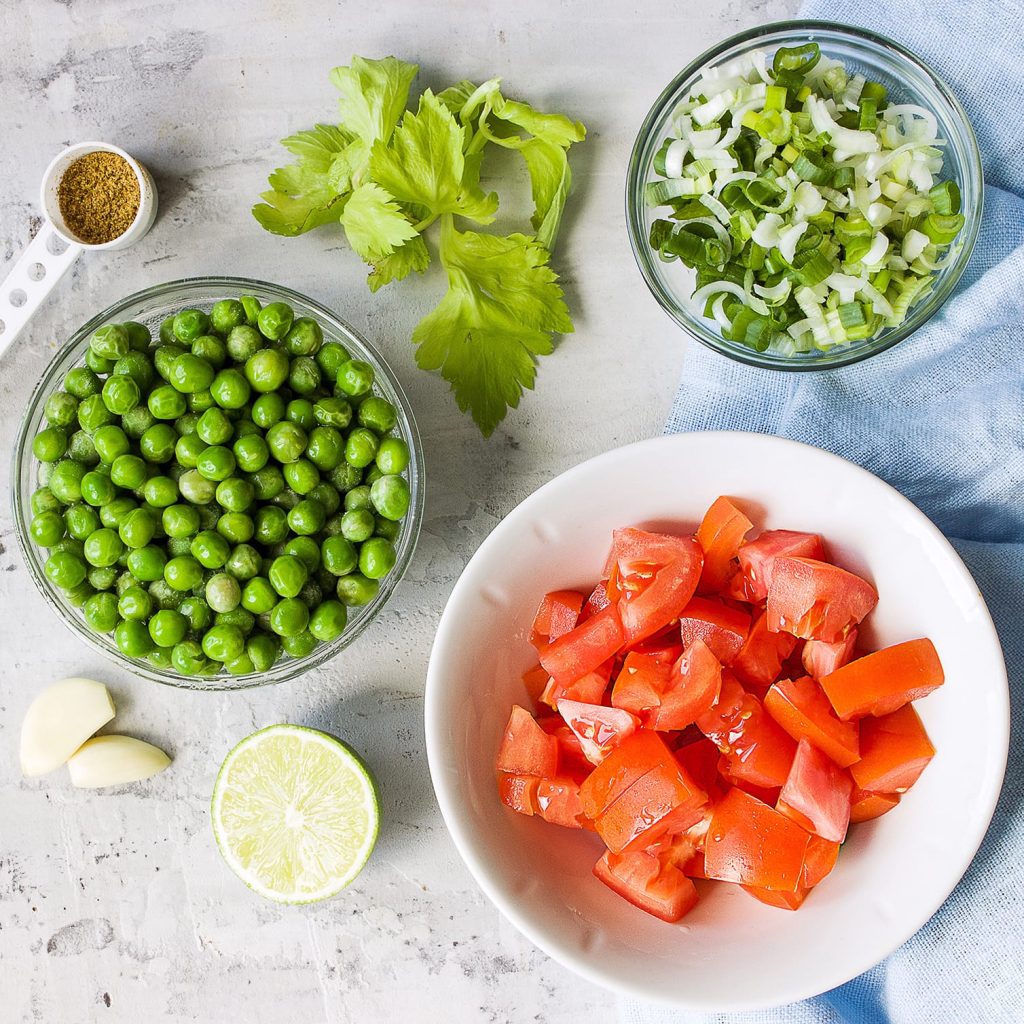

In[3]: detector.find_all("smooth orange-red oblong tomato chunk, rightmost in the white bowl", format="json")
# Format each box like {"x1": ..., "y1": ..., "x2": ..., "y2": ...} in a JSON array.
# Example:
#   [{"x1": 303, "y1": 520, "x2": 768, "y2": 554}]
[{"x1": 821, "y1": 640, "x2": 945, "y2": 721}]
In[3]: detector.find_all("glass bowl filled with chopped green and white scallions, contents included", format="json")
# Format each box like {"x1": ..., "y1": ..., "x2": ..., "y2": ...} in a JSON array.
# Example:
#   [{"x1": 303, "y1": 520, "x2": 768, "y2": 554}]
[{"x1": 626, "y1": 22, "x2": 983, "y2": 370}]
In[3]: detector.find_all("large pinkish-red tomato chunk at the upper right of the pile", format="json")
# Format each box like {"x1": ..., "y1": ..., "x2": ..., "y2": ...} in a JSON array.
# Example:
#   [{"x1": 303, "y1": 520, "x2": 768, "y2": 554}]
[{"x1": 768, "y1": 556, "x2": 879, "y2": 643}]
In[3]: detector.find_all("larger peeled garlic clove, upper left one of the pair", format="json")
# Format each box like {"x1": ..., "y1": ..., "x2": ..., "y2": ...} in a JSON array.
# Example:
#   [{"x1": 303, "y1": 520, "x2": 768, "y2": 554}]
[{"x1": 20, "y1": 678, "x2": 114, "y2": 775}]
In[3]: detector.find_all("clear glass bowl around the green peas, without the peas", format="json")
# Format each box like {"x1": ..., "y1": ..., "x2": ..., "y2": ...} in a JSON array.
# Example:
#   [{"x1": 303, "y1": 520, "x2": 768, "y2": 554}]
[{"x1": 12, "y1": 278, "x2": 425, "y2": 690}]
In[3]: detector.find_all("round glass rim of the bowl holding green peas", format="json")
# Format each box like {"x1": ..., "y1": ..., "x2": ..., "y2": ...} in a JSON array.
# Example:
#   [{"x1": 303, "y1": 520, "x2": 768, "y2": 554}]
[{"x1": 11, "y1": 274, "x2": 426, "y2": 693}]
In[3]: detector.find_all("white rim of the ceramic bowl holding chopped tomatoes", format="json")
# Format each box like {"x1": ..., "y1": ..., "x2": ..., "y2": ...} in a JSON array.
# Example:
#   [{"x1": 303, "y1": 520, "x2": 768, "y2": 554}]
[{"x1": 424, "y1": 430, "x2": 1011, "y2": 1013}]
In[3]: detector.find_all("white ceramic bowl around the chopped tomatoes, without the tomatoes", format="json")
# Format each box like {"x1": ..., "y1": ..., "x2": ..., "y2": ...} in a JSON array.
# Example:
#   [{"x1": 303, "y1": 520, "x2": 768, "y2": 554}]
[{"x1": 426, "y1": 432, "x2": 1010, "y2": 1011}]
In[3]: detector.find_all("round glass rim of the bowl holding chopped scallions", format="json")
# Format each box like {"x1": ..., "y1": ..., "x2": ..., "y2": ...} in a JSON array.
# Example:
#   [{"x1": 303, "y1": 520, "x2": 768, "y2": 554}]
[{"x1": 625, "y1": 18, "x2": 985, "y2": 373}]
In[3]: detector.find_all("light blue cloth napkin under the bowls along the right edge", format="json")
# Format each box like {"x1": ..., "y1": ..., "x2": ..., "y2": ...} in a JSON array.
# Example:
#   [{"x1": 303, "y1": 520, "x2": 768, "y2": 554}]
[{"x1": 621, "y1": 0, "x2": 1024, "y2": 1024}]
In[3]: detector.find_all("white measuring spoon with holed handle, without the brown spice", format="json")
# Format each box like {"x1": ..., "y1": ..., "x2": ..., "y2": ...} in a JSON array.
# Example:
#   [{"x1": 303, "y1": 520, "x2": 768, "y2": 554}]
[{"x1": 0, "y1": 142, "x2": 157, "y2": 356}]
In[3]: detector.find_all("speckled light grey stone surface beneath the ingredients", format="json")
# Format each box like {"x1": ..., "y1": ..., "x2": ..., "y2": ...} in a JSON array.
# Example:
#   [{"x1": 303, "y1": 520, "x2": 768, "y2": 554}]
[{"x1": 0, "y1": 0, "x2": 796, "y2": 1024}]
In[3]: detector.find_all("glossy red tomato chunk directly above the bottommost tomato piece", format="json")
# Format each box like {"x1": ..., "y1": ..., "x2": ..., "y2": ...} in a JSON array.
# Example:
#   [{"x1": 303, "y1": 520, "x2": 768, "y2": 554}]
[{"x1": 594, "y1": 748, "x2": 708, "y2": 853}]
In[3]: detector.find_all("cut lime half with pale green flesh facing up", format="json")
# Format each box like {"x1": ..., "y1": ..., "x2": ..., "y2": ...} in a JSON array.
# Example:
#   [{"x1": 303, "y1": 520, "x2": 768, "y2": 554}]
[{"x1": 210, "y1": 725, "x2": 380, "y2": 903}]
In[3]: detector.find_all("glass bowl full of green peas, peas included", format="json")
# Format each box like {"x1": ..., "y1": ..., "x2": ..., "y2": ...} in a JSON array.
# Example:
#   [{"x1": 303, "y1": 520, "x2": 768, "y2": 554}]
[{"x1": 13, "y1": 278, "x2": 424, "y2": 689}]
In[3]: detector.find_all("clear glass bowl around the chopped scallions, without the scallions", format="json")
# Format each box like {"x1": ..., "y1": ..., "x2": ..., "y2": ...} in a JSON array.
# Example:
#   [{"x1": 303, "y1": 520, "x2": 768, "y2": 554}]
[{"x1": 626, "y1": 22, "x2": 984, "y2": 370}]
